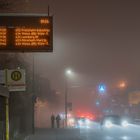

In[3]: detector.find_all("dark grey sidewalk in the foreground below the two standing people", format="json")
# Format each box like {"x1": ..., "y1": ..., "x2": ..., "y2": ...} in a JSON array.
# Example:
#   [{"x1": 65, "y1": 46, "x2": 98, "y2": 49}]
[{"x1": 25, "y1": 128, "x2": 80, "y2": 140}]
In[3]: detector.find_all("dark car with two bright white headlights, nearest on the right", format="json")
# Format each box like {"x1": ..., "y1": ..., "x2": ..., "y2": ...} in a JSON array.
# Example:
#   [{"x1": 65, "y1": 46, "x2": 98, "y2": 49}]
[{"x1": 100, "y1": 115, "x2": 131, "y2": 128}]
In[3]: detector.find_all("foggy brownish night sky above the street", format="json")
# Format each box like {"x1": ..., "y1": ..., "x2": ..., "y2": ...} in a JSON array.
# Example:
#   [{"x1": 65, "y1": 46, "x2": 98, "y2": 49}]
[{"x1": 2, "y1": 0, "x2": 140, "y2": 110}]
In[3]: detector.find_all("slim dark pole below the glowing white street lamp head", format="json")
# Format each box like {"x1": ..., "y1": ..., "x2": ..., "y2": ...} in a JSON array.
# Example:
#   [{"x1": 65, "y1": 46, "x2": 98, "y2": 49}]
[{"x1": 65, "y1": 78, "x2": 68, "y2": 128}]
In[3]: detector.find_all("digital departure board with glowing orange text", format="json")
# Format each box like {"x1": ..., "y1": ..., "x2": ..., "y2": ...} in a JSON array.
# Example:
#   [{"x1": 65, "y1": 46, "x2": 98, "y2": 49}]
[{"x1": 0, "y1": 14, "x2": 53, "y2": 52}]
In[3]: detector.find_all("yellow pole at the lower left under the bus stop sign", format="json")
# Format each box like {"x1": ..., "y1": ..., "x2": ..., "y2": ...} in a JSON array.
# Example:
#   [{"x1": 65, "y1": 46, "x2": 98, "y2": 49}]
[{"x1": 6, "y1": 97, "x2": 9, "y2": 140}]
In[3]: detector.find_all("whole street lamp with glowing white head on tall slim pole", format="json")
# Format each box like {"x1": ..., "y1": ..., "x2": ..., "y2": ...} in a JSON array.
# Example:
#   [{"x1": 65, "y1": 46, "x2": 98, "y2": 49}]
[{"x1": 65, "y1": 69, "x2": 73, "y2": 127}]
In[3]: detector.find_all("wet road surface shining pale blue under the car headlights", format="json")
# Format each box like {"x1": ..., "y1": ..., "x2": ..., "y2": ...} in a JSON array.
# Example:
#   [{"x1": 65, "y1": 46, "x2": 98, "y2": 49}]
[{"x1": 80, "y1": 122, "x2": 140, "y2": 140}]
